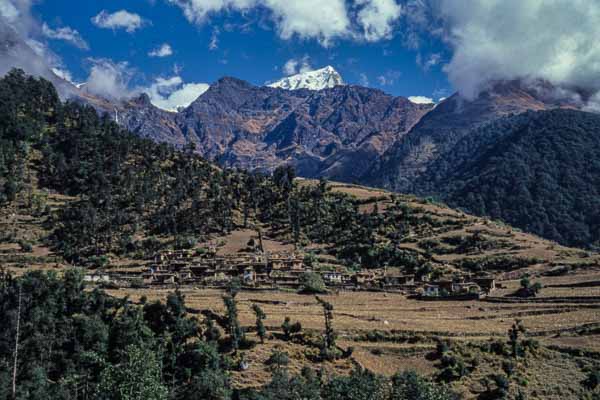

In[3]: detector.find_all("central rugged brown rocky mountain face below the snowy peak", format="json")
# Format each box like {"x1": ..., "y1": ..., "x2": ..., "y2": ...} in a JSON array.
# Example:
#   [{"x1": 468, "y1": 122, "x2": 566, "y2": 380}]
[{"x1": 88, "y1": 78, "x2": 433, "y2": 181}]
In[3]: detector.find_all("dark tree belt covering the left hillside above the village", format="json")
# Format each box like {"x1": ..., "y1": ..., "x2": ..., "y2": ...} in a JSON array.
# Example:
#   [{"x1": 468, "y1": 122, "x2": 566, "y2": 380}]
[{"x1": 0, "y1": 70, "x2": 460, "y2": 269}]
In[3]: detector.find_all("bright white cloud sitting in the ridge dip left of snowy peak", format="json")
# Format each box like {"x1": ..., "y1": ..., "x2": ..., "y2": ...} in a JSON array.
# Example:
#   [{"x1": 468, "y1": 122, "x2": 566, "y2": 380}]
[{"x1": 143, "y1": 76, "x2": 210, "y2": 111}]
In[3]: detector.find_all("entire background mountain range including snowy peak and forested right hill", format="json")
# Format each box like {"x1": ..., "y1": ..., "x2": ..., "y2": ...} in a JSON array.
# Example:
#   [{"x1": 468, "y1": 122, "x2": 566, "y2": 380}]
[{"x1": 0, "y1": 25, "x2": 600, "y2": 246}]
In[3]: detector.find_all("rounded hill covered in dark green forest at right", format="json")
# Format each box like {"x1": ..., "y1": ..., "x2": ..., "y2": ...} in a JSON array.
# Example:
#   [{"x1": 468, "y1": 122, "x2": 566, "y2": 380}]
[{"x1": 416, "y1": 110, "x2": 600, "y2": 248}]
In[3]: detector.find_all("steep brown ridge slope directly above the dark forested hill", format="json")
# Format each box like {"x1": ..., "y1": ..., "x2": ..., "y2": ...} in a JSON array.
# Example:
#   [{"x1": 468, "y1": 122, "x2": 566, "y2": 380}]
[{"x1": 362, "y1": 81, "x2": 580, "y2": 192}]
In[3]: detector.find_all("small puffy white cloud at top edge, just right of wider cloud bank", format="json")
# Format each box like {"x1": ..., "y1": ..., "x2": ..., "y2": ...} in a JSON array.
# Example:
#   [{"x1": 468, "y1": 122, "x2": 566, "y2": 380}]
[{"x1": 356, "y1": 0, "x2": 402, "y2": 42}]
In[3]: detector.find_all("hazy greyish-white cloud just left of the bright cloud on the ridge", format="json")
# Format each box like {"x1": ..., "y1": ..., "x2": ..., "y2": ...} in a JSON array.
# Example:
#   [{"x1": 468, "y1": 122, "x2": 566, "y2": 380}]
[{"x1": 85, "y1": 59, "x2": 133, "y2": 99}]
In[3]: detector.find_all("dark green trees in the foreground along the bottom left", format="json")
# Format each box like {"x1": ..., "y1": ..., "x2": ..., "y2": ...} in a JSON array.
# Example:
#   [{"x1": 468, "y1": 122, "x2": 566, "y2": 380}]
[{"x1": 0, "y1": 270, "x2": 457, "y2": 400}]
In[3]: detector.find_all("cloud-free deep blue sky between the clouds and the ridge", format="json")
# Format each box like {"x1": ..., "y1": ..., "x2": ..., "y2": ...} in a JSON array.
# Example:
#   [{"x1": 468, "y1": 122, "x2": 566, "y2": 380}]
[{"x1": 31, "y1": 0, "x2": 452, "y2": 108}]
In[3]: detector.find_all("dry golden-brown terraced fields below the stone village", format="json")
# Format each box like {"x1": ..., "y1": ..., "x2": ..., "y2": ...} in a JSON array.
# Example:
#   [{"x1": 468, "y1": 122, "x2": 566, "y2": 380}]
[{"x1": 111, "y1": 271, "x2": 600, "y2": 399}]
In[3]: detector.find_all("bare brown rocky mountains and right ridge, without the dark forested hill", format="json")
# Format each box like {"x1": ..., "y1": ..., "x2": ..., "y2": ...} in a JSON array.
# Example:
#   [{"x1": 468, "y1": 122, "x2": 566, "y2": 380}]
[{"x1": 85, "y1": 68, "x2": 581, "y2": 188}]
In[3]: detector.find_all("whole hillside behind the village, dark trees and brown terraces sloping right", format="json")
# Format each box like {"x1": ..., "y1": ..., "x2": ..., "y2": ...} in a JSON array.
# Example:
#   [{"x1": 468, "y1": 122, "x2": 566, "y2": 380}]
[{"x1": 0, "y1": 72, "x2": 593, "y2": 280}]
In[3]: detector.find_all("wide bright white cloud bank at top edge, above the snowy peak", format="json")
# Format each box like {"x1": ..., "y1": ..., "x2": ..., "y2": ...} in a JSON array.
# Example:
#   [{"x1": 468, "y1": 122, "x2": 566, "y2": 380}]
[{"x1": 169, "y1": 0, "x2": 351, "y2": 46}]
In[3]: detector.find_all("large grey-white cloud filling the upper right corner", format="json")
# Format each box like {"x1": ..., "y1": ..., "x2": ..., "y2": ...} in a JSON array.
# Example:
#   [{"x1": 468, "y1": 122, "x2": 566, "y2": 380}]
[{"x1": 433, "y1": 0, "x2": 600, "y2": 98}]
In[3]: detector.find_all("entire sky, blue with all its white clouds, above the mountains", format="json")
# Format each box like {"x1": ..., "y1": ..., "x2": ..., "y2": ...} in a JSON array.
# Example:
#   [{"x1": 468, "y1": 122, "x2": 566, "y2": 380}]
[{"x1": 7, "y1": 0, "x2": 600, "y2": 110}]
